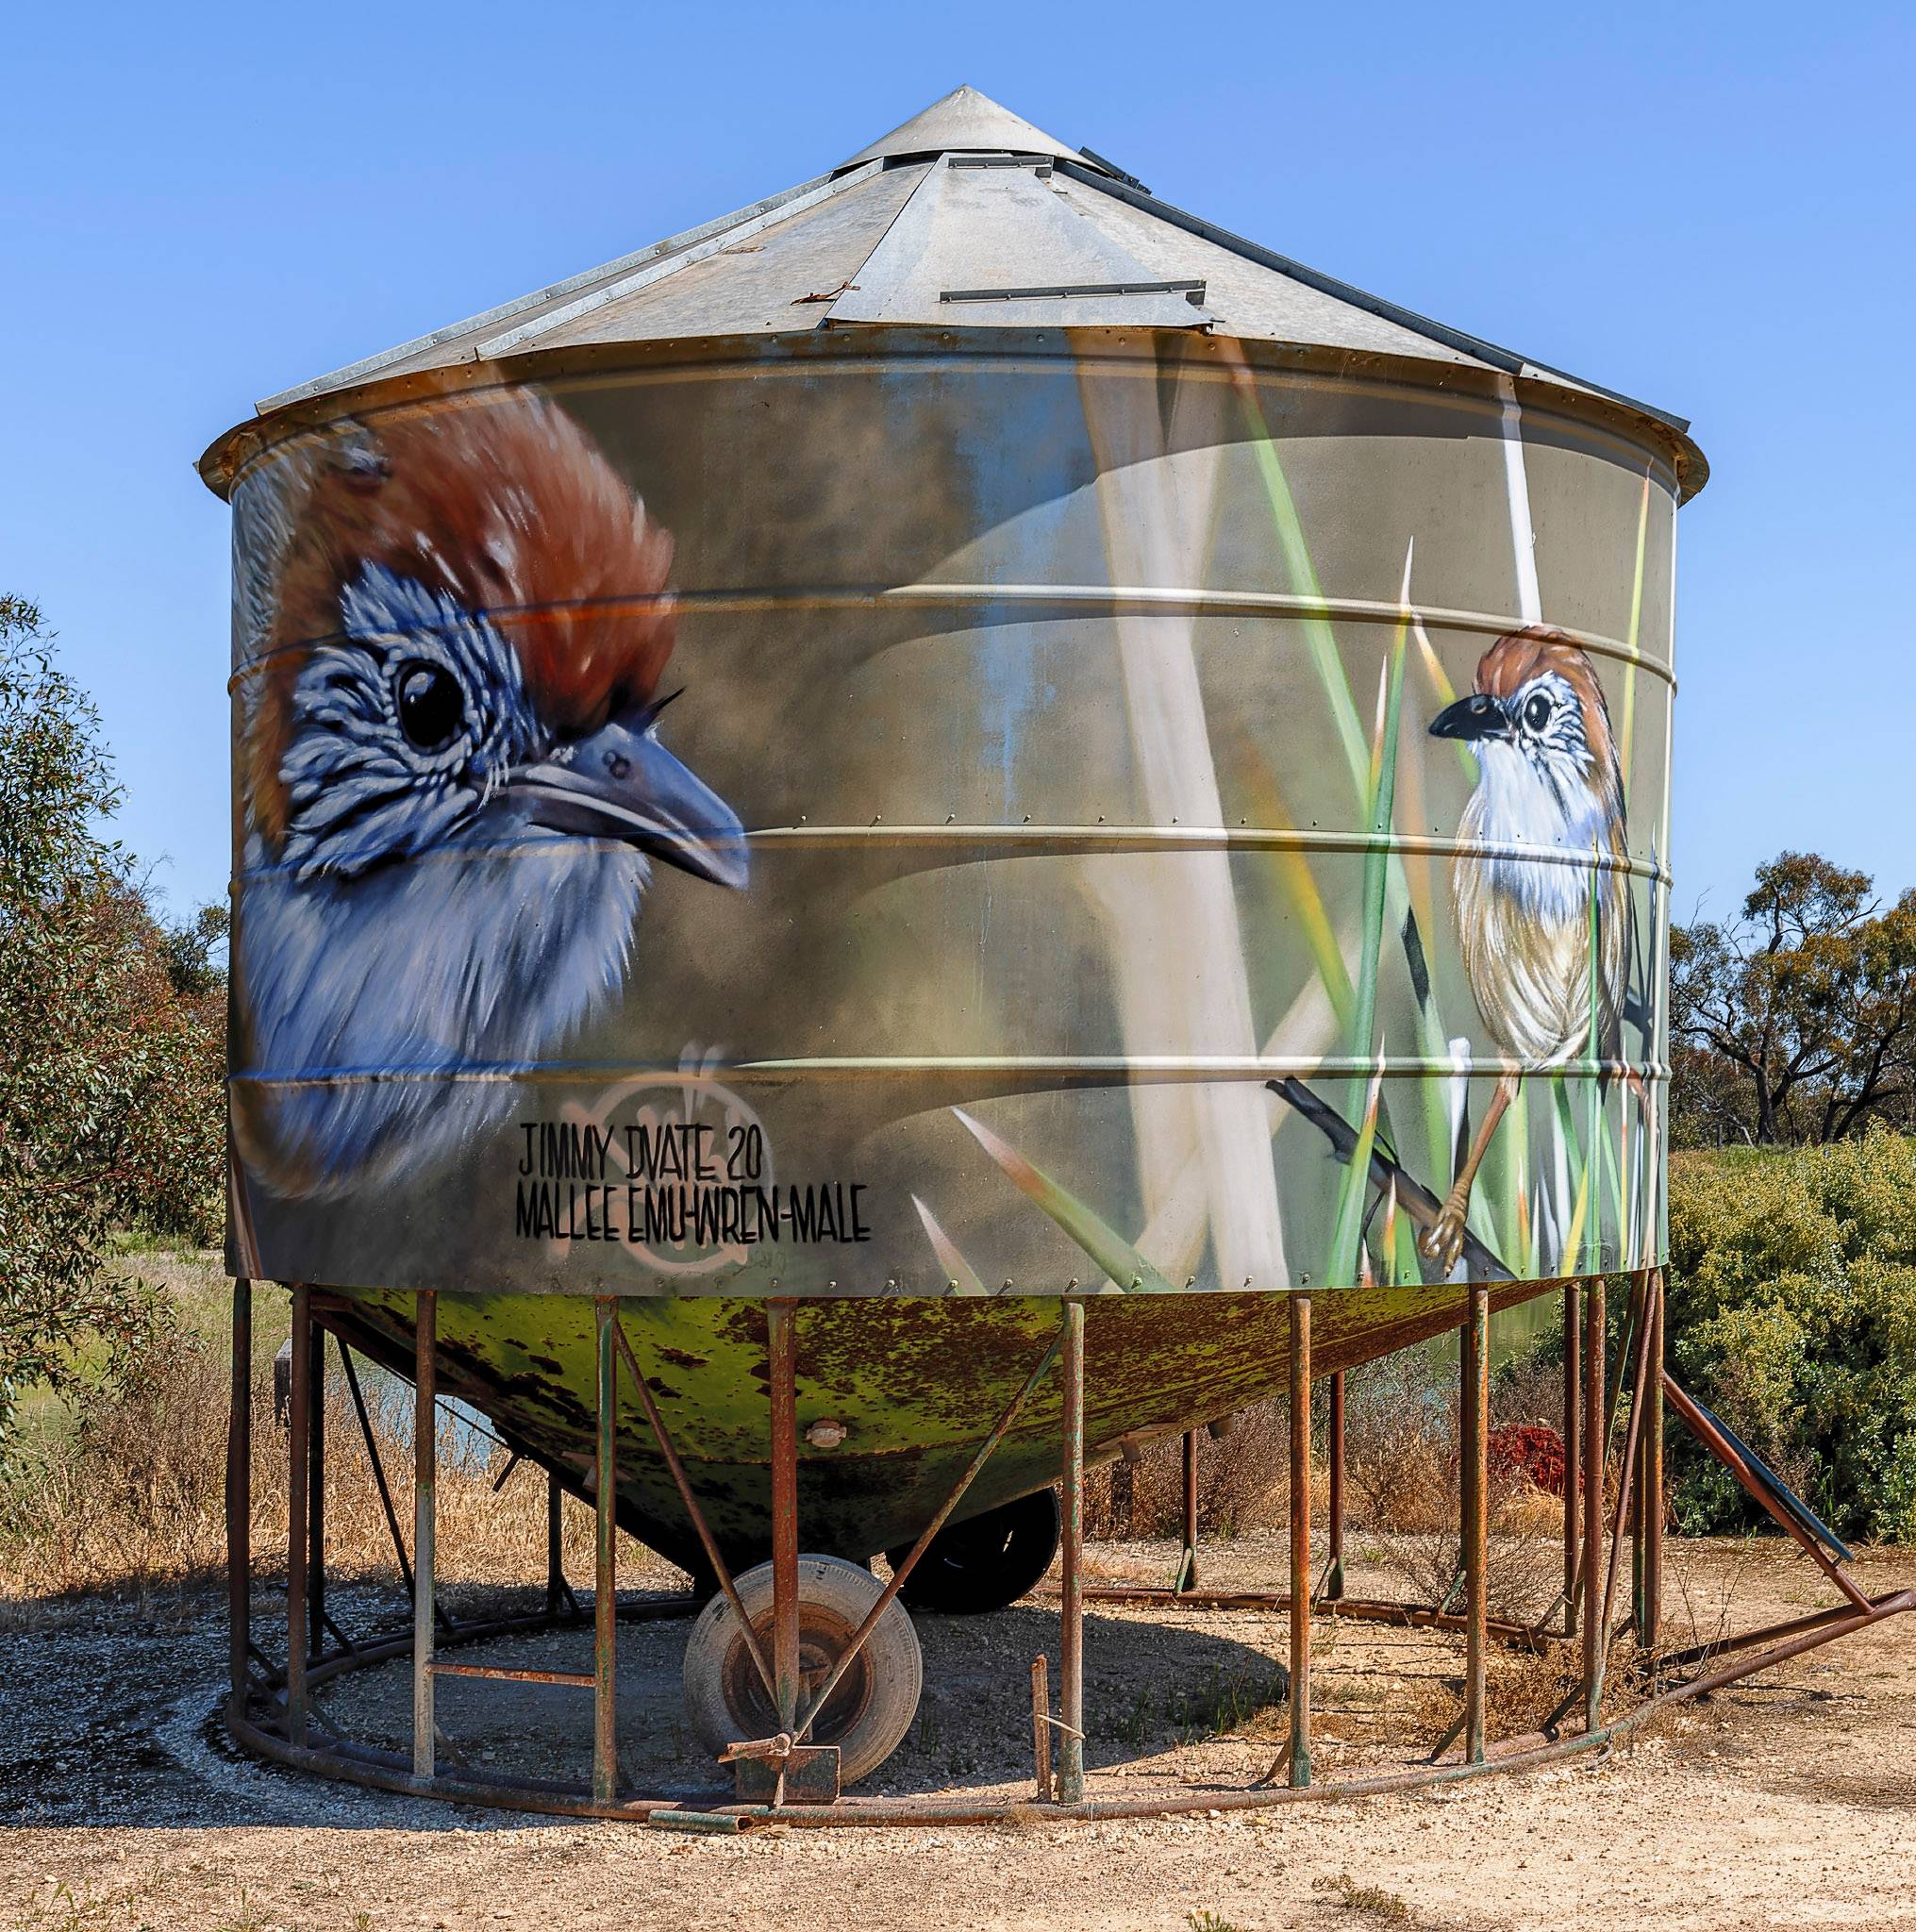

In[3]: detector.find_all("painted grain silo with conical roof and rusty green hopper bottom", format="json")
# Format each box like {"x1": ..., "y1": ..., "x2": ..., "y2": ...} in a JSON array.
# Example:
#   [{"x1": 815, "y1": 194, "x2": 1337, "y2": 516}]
[{"x1": 203, "y1": 89, "x2": 1706, "y2": 1803}]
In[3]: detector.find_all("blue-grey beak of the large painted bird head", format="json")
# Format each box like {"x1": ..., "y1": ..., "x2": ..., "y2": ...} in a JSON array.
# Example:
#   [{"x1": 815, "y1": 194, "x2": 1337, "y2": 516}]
[{"x1": 508, "y1": 706, "x2": 749, "y2": 887}]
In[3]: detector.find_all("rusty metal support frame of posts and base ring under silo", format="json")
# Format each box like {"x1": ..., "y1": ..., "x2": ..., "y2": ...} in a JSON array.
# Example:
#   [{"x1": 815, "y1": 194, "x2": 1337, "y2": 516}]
[{"x1": 226, "y1": 1272, "x2": 1916, "y2": 1829}]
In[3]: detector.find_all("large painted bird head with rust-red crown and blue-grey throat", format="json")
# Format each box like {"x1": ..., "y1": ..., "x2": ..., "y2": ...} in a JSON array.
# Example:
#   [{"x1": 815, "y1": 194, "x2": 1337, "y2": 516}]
[{"x1": 234, "y1": 391, "x2": 745, "y2": 1198}]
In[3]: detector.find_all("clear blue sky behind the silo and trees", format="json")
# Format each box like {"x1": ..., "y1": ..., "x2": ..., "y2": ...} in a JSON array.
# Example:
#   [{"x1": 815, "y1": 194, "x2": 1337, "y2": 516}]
[{"x1": 0, "y1": 0, "x2": 1916, "y2": 914}]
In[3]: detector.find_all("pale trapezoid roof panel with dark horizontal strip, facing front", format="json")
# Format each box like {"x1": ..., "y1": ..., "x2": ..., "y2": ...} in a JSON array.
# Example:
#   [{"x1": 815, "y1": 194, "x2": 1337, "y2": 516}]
[{"x1": 826, "y1": 157, "x2": 1211, "y2": 328}]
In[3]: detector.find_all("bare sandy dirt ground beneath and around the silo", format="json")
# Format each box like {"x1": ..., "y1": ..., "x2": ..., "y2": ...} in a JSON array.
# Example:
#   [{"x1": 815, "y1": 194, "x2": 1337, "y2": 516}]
[{"x1": 0, "y1": 1543, "x2": 1916, "y2": 1932}]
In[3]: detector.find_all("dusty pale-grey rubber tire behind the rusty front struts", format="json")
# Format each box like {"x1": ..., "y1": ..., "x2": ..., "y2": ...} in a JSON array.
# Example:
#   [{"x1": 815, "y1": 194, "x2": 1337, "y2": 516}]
[{"x1": 684, "y1": 1556, "x2": 925, "y2": 1785}]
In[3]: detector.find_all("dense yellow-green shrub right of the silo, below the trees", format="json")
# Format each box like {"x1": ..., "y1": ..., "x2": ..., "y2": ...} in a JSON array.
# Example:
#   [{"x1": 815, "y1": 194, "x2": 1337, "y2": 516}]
[{"x1": 1669, "y1": 1128, "x2": 1916, "y2": 1541}]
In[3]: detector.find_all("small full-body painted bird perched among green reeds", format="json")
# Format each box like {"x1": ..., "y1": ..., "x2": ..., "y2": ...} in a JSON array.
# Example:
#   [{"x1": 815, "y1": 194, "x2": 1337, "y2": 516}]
[{"x1": 1420, "y1": 628, "x2": 1628, "y2": 1274}]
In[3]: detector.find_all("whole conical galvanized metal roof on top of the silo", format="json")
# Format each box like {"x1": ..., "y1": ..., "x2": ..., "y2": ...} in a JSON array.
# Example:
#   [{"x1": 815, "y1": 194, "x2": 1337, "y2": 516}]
[{"x1": 235, "y1": 87, "x2": 1704, "y2": 492}]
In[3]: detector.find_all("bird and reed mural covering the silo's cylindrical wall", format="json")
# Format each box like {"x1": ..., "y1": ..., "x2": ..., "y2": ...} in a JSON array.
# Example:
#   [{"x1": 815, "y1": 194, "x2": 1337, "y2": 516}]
[{"x1": 232, "y1": 332, "x2": 1674, "y2": 1294}]
